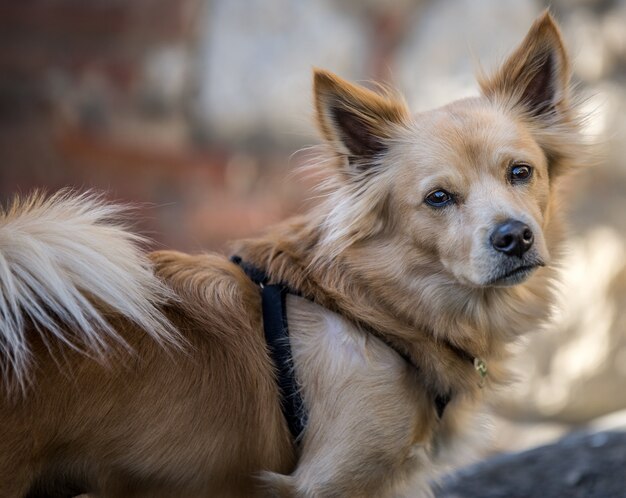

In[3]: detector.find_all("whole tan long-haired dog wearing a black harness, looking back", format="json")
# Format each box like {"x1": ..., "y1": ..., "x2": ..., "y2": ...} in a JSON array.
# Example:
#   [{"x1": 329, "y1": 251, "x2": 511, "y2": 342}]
[{"x1": 0, "y1": 12, "x2": 586, "y2": 498}]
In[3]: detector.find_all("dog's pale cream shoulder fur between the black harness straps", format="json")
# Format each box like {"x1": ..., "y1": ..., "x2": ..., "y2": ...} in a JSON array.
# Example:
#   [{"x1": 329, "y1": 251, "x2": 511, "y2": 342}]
[{"x1": 287, "y1": 296, "x2": 448, "y2": 496}]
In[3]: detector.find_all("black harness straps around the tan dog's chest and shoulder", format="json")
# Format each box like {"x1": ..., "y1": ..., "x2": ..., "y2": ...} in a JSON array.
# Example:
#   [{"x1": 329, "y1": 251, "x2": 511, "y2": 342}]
[{"x1": 230, "y1": 256, "x2": 452, "y2": 442}]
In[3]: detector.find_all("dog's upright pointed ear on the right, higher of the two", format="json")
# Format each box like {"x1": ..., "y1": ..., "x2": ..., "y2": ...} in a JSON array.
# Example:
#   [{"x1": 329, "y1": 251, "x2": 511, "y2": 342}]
[{"x1": 479, "y1": 10, "x2": 570, "y2": 118}]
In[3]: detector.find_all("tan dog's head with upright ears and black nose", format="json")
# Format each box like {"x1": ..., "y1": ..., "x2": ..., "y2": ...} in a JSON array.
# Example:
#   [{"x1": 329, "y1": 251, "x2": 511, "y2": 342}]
[{"x1": 314, "y1": 13, "x2": 579, "y2": 287}]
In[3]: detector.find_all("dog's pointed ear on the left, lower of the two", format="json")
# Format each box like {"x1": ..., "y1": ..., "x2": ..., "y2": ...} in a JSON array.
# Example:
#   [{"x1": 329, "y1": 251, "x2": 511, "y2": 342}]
[{"x1": 313, "y1": 69, "x2": 409, "y2": 164}]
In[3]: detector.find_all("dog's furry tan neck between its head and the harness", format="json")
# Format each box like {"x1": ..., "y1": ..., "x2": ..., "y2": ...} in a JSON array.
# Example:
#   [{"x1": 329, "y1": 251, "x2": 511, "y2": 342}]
[{"x1": 234, "y1": 213, "x2": 551, "y2": 393}]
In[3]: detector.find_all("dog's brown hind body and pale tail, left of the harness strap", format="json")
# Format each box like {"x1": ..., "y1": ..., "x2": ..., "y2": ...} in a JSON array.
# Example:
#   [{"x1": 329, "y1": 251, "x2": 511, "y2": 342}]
[{"x1": 0, "y1": 194, "x2": 292, "y2": 497}]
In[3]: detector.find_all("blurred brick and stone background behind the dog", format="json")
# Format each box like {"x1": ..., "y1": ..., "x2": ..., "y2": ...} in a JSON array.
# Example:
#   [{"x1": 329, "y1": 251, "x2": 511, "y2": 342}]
[{"x1": 0, "y1": 0, "x2": 626, "y2": 470}]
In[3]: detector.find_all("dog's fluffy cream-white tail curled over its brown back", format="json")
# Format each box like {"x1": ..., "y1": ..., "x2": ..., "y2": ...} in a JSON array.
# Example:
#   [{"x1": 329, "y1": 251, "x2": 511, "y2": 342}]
[{"x1": 0, "y1": 191, "x2": 178, "y2": 387}]
